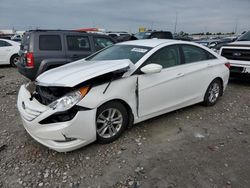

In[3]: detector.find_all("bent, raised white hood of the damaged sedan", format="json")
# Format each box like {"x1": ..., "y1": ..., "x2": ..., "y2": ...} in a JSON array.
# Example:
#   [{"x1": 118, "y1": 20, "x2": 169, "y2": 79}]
[{"x1": 36, "y1": 59, "x2": 133, "y2": 87}]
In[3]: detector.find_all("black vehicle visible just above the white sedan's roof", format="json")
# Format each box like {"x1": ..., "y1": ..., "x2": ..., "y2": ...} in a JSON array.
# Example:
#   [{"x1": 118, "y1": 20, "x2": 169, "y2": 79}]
[{"x1": 134, "y1": 31, "x2": 173, "y2": 39}]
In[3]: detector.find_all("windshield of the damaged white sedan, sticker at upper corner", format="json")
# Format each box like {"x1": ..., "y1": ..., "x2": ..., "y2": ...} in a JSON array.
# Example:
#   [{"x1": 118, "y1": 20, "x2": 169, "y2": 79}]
[{"x1": 85, "y1": 45, "x2": 151, "y2": 64}]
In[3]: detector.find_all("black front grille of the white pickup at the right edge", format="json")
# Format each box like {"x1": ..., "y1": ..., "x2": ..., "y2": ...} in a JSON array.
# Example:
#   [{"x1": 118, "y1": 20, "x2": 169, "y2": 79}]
[{"x1": 221, "y1": 48, "x2": 250, "y2": 61}]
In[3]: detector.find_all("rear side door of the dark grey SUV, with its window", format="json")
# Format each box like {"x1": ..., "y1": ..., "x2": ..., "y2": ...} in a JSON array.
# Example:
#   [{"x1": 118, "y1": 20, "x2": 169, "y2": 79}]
[{"x1": 64, "y1": 34, "x2": 94, "y2": 62}]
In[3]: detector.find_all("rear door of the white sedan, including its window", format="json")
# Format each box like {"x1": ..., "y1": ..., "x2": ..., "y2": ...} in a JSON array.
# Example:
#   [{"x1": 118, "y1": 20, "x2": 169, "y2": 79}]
[{"x1": 181, "y1": 44, "x2": 218, "y2": 102}]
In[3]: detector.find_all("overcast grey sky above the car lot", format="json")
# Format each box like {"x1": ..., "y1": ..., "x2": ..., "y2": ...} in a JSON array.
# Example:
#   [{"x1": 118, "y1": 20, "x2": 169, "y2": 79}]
[{"x1": 0, "y1": 0, "x2": 250, "y2": 33}]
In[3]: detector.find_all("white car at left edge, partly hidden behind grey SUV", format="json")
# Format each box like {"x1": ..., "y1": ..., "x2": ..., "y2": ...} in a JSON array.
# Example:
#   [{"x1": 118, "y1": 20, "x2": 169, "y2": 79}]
[{"x1": 0, "y1": 38, "x2": 20, "y2": 67}]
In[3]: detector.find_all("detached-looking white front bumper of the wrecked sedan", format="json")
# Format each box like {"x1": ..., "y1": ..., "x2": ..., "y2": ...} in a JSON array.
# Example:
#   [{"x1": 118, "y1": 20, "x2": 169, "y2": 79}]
[{"x1": 17, "y1": 85, "x2": 96, "y2": 152}]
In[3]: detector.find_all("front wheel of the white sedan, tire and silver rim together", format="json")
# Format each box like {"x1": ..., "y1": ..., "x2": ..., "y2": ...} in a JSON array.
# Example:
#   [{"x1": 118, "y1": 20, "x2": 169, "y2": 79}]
[{"x1": 96, "y1": 101, "x2": 129, "y2": 144}]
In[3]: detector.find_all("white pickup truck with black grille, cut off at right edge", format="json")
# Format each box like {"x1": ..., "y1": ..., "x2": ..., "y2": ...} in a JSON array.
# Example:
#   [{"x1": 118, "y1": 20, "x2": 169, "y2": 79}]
[{"x1": 219, "y1": 31, "x2": 250, "y2": 76}]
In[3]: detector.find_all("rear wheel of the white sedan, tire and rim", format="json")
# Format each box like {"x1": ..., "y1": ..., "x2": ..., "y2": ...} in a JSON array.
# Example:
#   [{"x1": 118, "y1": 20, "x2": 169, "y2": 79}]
[{"x1": 203, "y1": 79, "x2": 223, "y2": 106}]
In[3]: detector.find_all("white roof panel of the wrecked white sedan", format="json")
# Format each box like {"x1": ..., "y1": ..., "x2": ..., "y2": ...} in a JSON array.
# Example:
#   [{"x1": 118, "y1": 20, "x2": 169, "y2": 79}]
[{"x1": 117, "y1": 39, "x2": 178, "y2": 48}]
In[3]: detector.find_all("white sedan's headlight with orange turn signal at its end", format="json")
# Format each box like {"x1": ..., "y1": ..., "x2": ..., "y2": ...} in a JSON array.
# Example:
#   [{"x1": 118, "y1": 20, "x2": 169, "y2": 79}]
[{"x1": 49, "y1": 86, "x2": 90, "y2": 111}]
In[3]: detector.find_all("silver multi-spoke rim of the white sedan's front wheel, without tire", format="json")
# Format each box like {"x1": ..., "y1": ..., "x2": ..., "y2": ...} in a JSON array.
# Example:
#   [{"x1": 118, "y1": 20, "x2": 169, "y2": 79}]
[{"x1": 96, "y1": 108, "x2": 123, "y2": 138}]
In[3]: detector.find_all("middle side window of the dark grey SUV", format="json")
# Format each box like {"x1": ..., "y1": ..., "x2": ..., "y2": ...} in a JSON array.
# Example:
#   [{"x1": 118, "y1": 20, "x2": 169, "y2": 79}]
[{"x1": 67, "y1": 36, "x2": 90, "y2": 51}]
